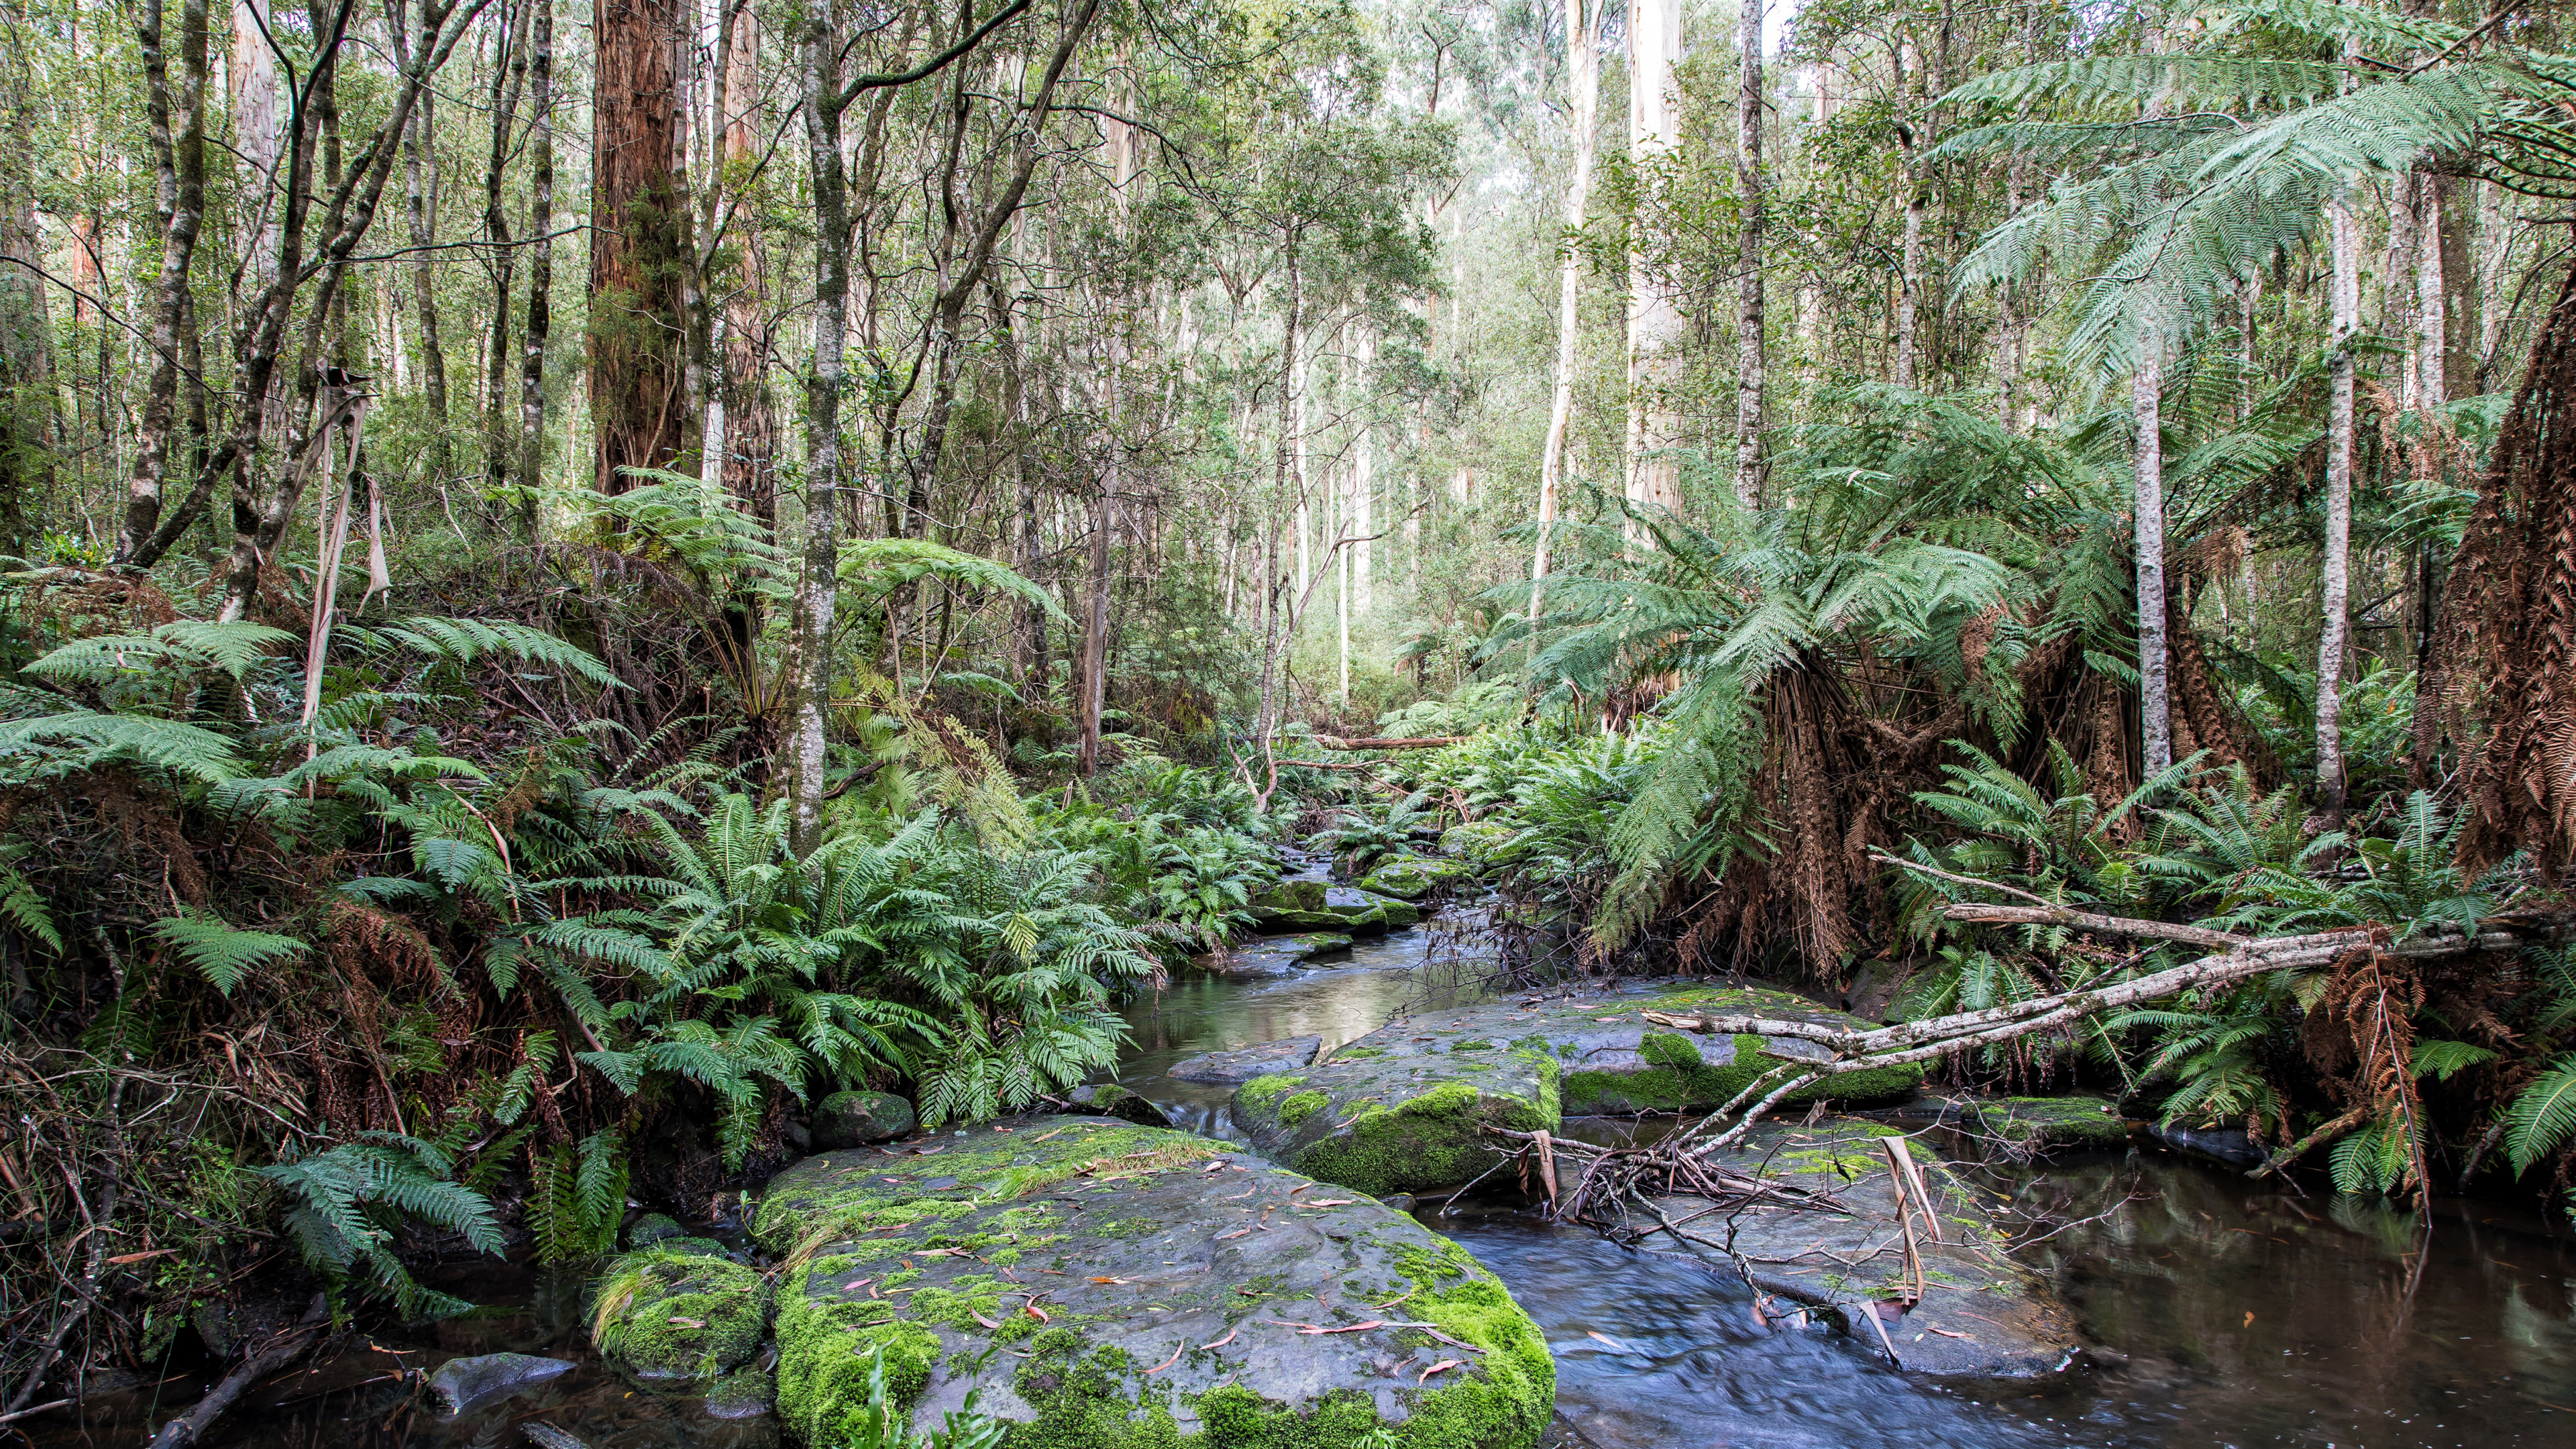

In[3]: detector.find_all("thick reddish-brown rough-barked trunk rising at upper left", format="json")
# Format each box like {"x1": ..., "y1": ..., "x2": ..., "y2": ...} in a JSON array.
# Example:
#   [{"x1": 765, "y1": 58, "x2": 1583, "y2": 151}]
[{"x1": 590, "y1": 0, "x2": 690, "y2": 492}]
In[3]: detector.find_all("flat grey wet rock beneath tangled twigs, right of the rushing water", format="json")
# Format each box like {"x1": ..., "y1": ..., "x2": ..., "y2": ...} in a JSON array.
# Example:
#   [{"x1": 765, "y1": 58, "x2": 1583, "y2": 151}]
[{"x1": 1649, "y1": 1119, "x2": 2082, "y2": 1379}]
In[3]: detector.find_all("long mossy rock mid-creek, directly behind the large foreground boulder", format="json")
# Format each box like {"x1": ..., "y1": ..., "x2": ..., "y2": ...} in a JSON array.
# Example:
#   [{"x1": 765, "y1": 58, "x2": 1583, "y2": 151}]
[{"x1": 1234, "y1": 979, "x2": 1922, "y2": 1196}]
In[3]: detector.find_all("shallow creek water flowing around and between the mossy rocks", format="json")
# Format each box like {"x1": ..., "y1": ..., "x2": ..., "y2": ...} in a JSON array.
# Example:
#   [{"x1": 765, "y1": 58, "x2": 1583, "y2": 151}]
[{"x1": 35, "y1": 912, "x2": 2576, "y2": 1449}]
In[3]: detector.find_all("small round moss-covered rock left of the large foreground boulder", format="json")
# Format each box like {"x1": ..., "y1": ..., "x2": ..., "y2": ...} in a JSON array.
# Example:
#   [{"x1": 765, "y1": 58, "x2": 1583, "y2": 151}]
[{"x1": 590, "y1": 1248, "x2": 770, "y2": 1382}]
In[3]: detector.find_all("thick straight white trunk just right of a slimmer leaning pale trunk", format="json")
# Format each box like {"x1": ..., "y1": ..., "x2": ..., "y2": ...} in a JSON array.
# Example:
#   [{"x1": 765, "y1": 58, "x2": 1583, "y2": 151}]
[{"x1": 1628, "y1": 0, "x2": 1690, "y2": 523}]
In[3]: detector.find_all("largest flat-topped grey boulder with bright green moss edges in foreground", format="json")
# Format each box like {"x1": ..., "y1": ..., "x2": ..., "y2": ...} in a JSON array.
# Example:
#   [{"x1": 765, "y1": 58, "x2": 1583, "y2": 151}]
[{"x1": 755, "y1": 1116, "x2": 1556, "y2": 1449}]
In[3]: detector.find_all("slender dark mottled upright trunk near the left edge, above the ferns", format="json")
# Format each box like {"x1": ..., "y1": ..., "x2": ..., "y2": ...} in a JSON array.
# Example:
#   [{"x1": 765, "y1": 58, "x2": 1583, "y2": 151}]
[{"x1": 111, "y1": 0, "x2": 211, "y2": 568}]
